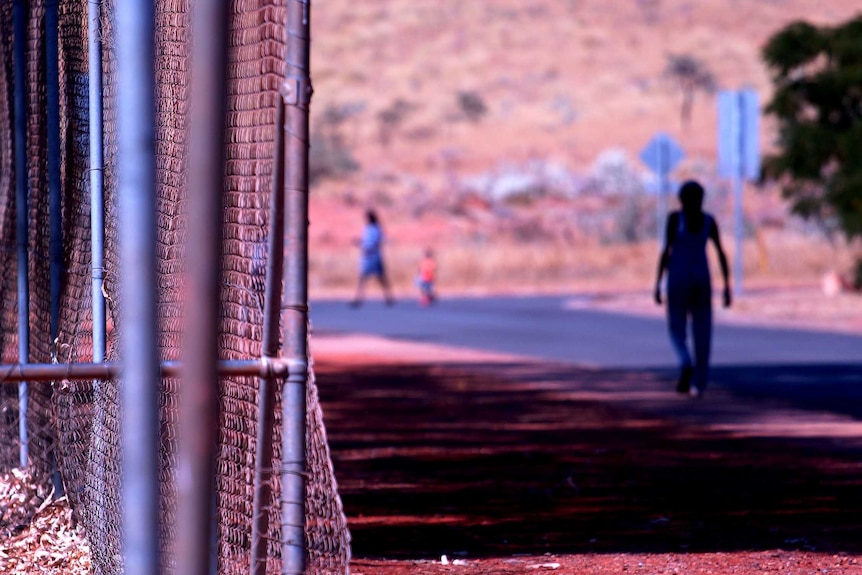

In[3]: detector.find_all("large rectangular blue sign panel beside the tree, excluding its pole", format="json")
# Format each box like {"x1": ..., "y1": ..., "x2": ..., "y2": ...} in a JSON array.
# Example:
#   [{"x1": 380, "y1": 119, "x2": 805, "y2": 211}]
[{"x1": 718, "y1": 90, "x2": 760, "y2": 180}]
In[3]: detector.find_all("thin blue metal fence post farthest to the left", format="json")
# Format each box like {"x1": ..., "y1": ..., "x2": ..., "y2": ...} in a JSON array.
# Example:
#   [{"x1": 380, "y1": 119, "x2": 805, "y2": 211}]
[{"x1": 12, "y1": 0, "x2": 30, "y2": 467}]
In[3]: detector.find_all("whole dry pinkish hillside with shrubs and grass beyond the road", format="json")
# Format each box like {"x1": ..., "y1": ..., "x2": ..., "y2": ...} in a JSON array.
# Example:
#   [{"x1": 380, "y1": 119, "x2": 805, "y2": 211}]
[{"x1": 304, "y1": 0, "x2": 860, "y2": 304}]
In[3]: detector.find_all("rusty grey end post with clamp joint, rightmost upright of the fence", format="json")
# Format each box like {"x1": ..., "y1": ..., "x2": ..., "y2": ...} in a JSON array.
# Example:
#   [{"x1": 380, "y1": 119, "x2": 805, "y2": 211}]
[{"x1": 281, "y1": 0, "x2": 312, "y2": 575}]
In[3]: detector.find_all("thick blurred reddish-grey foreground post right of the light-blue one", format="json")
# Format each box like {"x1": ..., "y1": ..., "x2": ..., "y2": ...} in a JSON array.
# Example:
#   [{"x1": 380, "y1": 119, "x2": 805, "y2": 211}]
[{"x1": 177, "y1": 0, "x2": 228, "y2": 575}]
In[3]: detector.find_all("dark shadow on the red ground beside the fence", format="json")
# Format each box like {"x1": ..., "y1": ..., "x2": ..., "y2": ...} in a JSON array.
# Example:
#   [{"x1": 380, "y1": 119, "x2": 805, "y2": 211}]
[{"x1": 318, "y1": 364, "x2": 862, "y2": 558}]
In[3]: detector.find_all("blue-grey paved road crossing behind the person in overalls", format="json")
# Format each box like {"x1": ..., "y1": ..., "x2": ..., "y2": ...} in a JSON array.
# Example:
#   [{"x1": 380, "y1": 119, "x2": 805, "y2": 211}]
[{"x1": 311, "y1": 297, "x2": 862, "y2": 369}]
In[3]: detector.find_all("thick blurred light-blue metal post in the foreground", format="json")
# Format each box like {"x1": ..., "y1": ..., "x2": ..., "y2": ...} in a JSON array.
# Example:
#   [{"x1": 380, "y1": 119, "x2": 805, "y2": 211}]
[{"x1": 115, "y1": 0, "x2": 161, "y2": 575}]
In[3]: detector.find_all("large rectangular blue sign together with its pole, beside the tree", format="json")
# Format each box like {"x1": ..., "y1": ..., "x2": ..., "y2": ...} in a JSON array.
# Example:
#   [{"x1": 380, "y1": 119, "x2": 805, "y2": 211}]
[{"x1": 718, "y1": 90, "x2": 760, "y2": 296}]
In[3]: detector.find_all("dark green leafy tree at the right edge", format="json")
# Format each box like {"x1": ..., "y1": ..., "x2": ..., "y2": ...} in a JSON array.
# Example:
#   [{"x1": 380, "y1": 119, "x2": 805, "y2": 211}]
[{"x1": 763, "y1": 16, "x2": 862, "y2": 248}]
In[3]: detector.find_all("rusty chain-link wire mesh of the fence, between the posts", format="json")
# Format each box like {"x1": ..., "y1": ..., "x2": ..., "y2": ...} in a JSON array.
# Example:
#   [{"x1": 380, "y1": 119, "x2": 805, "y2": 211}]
[{"x1": 0, "y1": 0, "x2": 350, "y2": 575}]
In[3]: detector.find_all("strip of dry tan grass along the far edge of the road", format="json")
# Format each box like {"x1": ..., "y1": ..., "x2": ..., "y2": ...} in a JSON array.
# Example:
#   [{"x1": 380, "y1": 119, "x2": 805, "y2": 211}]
[{"x1": 310, "y1": 232, "x2": 855, "y2": 297}]
